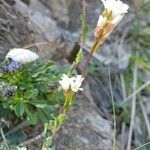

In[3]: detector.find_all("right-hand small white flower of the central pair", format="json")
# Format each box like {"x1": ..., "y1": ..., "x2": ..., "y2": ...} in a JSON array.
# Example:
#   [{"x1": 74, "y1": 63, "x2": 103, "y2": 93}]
[{"x1": 71, "y1": 75, "x2": 84, "y2": 92}]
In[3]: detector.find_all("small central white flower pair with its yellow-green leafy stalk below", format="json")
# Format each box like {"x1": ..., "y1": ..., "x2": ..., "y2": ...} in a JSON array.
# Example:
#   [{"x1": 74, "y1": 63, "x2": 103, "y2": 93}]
[{"x1": 48, "y1": 74, "x2": 84, "y2": 136}]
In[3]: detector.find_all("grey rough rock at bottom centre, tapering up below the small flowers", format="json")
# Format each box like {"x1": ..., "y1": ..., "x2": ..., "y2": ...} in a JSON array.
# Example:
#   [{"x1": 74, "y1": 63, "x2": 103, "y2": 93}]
[{"x1": 54, "y1": 84, "x2": 112, "y2": 150}]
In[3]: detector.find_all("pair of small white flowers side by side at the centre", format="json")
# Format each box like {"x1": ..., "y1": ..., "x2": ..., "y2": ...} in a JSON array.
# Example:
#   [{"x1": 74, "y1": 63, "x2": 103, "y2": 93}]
[{"x1": 59, "y1": 74, "x2": 84, "y2": 92}]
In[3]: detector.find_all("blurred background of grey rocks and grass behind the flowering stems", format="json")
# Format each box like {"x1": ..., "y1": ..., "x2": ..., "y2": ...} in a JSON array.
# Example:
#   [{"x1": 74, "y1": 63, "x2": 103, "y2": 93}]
[{"x1": 0, "y1": 0, "x2": 150, "y2": 150}]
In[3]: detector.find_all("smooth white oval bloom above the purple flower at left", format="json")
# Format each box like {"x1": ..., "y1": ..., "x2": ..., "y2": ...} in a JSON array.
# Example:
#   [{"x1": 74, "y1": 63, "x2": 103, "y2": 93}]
[{"x1": 6, "y1": 48, "x2": 39, "y2": 64}]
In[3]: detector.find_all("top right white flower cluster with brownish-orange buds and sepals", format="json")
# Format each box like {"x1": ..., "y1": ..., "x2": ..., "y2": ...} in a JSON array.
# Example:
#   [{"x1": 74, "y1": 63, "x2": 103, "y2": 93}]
[{"x1": 94, "y1": 0, "x2": 129, "y2": 44}]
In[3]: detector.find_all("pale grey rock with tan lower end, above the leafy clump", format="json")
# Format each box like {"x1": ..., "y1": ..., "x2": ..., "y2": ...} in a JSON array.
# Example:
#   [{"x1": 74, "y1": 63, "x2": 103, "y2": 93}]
[{"x1": 15, "y1": 0, "x2": 62, "y2": 59}]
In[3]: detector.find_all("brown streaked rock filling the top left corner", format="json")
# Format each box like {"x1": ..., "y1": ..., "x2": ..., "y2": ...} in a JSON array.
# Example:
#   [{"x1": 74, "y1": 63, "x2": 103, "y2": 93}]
[{"x1": 0, "y1": 1, "x2": 34, "y2": 61}]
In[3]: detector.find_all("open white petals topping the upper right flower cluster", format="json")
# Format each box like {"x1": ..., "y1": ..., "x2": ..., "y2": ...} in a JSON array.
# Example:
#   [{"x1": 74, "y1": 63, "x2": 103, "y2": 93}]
[{"x1": 101, "y1": 0, "x2": 129, "y2": 17}]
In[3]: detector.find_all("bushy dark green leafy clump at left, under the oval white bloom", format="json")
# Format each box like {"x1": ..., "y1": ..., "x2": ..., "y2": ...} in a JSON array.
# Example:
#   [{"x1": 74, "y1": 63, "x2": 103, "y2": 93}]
[{"x1": 0, "y1": 61, "x2": 63, "y2": 124}]
